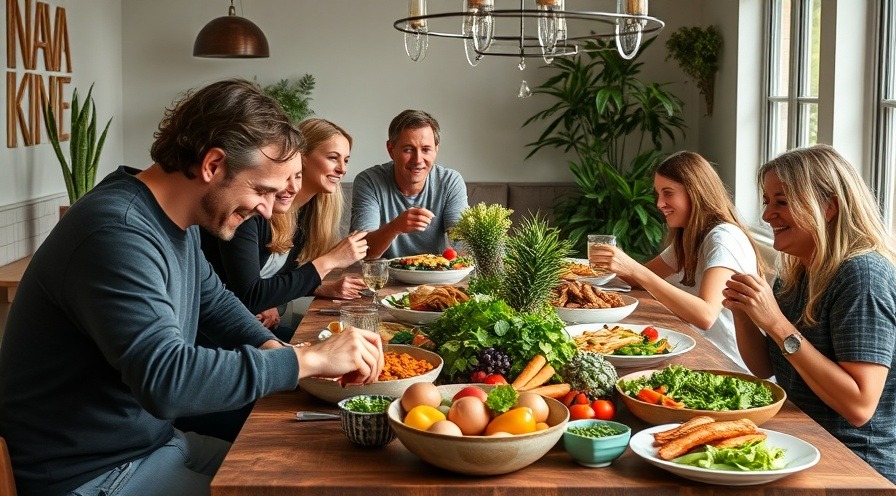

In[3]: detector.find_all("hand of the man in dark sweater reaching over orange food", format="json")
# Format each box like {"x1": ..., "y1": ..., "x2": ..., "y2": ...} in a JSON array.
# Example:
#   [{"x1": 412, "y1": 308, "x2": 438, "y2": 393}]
[{"x1": 295, "y1": 327, "x2": 384, "y2": 385}]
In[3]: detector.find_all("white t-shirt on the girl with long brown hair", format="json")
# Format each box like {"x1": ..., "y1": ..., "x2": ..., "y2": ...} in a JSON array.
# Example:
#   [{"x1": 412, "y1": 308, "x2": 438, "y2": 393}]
[{"x1": 660, "y1": 224, "x2": 758, "y2": 370}]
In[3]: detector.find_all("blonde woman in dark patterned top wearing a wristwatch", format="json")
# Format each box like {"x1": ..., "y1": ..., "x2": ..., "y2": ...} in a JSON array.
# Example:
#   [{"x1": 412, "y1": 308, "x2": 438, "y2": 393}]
[{"x1": 724, "y1": 145, "x2": 896, "y2": 482}]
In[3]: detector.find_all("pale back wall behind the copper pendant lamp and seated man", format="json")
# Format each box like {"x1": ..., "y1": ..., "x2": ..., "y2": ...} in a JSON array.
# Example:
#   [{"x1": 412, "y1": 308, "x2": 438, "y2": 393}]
[{"x1": 122, "y1": 0, "x2": 702, "y2": 182}]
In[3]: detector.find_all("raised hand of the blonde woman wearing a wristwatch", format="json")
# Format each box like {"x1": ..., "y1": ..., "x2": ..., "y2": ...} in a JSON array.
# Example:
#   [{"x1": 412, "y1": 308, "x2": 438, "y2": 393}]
[{"x1": 722, "y1": 274, "x2": 790, "y2": 341}]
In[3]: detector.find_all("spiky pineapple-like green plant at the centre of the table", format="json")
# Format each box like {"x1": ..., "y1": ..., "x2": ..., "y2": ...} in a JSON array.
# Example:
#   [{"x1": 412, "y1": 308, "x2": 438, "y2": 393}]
[{"x1": 500, "y1": 215, "x2": 572, "y2": 312}]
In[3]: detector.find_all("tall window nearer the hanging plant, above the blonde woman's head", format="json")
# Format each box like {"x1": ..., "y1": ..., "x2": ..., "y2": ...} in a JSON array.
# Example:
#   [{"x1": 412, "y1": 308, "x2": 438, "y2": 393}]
[{"x1": 764, "y1": 0, "x2": 821, "y2": 160}]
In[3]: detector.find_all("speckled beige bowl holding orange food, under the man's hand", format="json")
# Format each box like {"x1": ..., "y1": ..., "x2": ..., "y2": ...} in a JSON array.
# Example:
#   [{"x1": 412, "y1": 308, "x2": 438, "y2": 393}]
[{"x1": 299, "y1": 344, "x2": 444, "y2": 403}]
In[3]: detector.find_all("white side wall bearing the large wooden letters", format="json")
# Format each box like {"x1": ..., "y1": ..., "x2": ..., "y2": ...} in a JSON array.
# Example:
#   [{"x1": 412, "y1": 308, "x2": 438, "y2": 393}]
[{"x1": 0, "y1": 0, "x2": 123, "y2": 206}]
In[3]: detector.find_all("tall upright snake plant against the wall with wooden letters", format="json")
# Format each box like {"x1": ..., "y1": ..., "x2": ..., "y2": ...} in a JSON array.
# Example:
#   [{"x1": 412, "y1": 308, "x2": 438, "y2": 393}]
[{"x1": 44, "y1": 84, "x2": 112, "y2": 205}]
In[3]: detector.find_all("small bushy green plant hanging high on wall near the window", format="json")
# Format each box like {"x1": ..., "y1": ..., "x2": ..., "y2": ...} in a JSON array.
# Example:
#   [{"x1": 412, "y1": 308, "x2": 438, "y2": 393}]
[{"x1": 666, "y1": 26, "x2": 722, "y2": 115}]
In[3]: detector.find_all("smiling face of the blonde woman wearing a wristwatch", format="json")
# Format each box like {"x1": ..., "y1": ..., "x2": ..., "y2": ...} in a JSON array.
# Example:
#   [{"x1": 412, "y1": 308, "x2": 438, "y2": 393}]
[{"x1": 762, "y1": 171, "x2": 815, "y2": 265}]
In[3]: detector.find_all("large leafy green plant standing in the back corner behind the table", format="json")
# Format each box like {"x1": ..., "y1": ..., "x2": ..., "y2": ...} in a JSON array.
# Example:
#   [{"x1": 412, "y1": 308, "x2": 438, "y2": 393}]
[{"x1": 524, "y1": 40, "x2": 685, "y2": 260}]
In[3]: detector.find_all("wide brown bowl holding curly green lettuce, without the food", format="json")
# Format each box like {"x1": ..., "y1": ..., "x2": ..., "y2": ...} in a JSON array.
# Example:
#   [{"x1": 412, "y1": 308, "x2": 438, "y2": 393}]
[{"x1": 616, "y1": 370, "x2": 787, "y2": 425}]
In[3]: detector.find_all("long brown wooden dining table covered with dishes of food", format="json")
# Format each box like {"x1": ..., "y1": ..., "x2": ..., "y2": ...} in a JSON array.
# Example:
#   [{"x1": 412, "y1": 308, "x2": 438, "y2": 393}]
[{"x1": 211, "y1": 280, "x2": 896, "y2": 496}]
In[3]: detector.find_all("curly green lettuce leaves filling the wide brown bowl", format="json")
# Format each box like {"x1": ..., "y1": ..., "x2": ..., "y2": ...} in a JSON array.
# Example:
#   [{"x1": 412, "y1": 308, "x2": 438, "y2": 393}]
[{"x1": 622, "y1": 365, "x2": 775, "y2": 410}]
